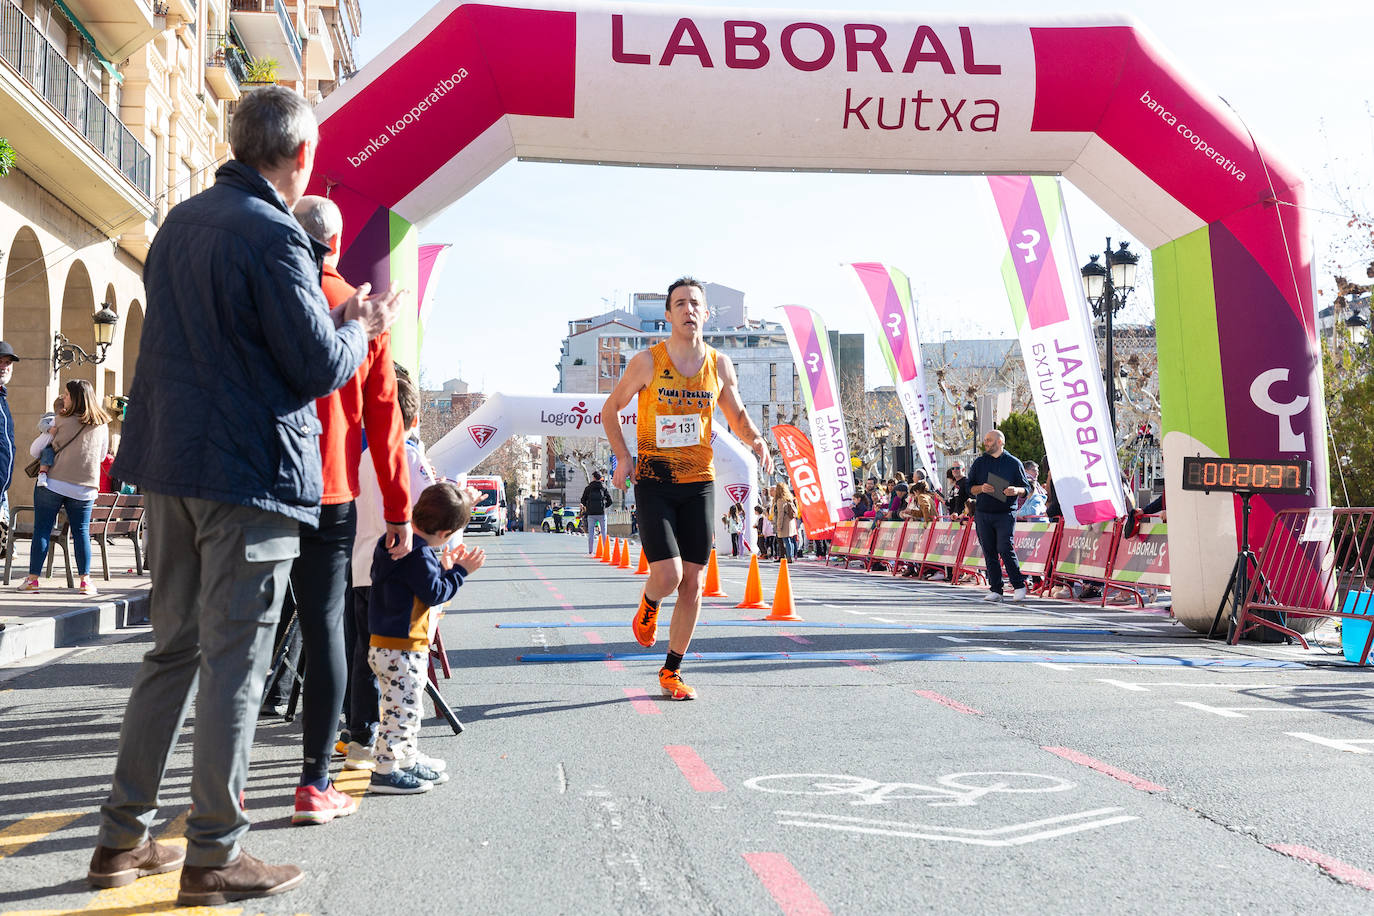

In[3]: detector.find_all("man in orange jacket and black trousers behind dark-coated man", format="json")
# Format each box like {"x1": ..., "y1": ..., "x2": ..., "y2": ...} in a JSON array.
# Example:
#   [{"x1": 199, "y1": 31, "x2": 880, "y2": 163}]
[{"x1": 291, "y1": 195, "x2": 411, "y2": 824}]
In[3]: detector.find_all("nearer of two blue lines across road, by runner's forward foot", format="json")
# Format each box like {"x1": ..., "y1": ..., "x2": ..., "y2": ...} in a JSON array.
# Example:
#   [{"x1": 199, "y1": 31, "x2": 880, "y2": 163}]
[{"x1": 517, "y1": 652, "x2": 1307, "y2": 669}]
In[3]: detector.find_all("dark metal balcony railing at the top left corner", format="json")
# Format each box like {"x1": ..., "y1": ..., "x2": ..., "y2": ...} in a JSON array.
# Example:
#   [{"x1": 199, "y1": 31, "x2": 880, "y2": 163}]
[{"x1": 0, "y1": 0, "x2": 153, "y2": 201}]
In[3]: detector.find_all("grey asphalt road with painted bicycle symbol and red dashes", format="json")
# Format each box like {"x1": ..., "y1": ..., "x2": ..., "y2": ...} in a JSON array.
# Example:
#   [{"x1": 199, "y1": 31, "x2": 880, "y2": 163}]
[{"x1": 0, "y1": 533, "x2": 1374, "y2": 916}]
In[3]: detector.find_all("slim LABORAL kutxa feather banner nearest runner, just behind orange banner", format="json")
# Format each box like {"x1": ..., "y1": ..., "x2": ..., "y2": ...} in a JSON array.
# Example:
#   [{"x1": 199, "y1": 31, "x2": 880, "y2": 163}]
[{"x1": 782, "y1": 305, "x2": 855, "y2": 522}]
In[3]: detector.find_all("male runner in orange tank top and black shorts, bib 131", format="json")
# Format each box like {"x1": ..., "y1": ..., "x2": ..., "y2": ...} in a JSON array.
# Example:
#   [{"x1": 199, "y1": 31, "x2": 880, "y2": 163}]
[{"x1": 602, "y1": 277, "x2": 772, "y2": 700}]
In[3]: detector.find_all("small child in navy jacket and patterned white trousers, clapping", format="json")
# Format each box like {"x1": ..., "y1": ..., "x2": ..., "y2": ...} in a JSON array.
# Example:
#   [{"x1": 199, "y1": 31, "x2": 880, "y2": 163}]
[{"x1": 367, "y1": 482, "x2": 486, "y2": 795}]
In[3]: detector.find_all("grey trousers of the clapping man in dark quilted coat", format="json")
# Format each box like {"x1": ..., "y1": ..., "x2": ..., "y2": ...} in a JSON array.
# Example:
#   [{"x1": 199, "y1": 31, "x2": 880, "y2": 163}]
[{"x1": 98, "y1": 493, "x2": 300, "y2": 867}]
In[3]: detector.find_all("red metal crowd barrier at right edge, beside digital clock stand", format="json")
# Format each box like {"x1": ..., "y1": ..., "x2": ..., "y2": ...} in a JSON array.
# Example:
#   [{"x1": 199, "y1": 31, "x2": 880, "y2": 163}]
[{"x1": 1231, "y1": 508, "x2": 1374, "y2": 665}]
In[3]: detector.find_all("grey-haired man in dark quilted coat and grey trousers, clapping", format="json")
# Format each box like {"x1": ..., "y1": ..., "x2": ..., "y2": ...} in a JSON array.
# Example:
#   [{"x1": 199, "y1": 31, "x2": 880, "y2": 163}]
[{"x1": 87, "y1": 87, "x2": 400, "y2": 906}]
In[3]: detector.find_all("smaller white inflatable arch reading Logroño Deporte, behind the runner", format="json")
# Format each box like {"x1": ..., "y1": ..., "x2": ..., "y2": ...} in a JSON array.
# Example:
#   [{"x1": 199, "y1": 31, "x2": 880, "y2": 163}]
[{"x1": 429, "y1": 394, "x2": 758, "y2": 545}]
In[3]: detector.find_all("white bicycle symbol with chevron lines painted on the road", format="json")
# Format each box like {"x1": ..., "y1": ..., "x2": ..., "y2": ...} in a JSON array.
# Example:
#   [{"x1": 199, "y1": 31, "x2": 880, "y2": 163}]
[{"x1": 745, "y1": 772, "x2": 1138, "y2": 846}]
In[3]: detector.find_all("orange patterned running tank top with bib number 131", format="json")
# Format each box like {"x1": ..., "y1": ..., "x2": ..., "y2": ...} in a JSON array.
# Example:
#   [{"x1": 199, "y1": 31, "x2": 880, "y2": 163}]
[{"x1": 635, "y1": 343, "x2": 720, "y2": 483}]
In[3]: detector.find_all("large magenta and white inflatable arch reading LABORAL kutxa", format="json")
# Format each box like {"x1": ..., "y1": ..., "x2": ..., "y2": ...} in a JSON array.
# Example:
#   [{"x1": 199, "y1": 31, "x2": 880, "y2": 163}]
[{"x1": 313, "y1": 0, "x2": 1329, "y2": 629}]
